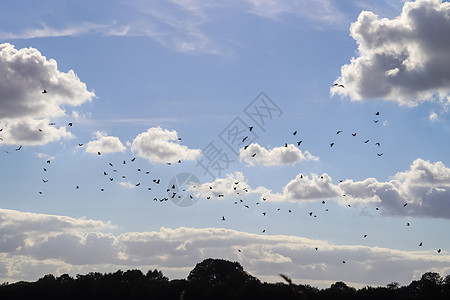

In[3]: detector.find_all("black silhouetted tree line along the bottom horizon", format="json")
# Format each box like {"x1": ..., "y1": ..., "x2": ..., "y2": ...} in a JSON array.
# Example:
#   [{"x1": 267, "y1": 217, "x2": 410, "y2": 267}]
[{"x1": 0, "y1": 258, "x2": 450, "y2": 300}]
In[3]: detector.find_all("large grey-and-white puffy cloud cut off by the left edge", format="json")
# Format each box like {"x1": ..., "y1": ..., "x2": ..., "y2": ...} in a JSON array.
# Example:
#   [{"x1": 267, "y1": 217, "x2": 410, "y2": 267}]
[{"x1": 0, "y1": 43, "x2": 95, "y2": 145}]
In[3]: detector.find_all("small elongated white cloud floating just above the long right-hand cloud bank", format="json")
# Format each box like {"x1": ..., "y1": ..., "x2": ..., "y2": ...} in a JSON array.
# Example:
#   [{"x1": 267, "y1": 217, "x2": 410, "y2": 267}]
[{"x1": 239, "y1": 143, "x2": 319, "y2": 166}]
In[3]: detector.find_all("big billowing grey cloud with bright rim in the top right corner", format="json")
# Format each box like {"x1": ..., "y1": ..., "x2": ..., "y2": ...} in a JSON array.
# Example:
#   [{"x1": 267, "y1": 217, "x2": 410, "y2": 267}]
[{"x1": 331, "y1": 0, "x2": 450, "y2": 106}]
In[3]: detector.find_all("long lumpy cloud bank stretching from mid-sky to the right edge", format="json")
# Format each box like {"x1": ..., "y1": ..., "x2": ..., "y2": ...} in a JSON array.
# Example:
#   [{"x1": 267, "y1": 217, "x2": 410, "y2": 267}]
[{"x1": 197, "y1": 158, "x2": 450, "y2": 219}]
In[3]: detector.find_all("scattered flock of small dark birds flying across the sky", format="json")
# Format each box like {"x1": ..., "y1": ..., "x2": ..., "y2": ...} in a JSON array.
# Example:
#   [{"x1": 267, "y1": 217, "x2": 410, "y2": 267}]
[{"x1": 0, "y1": 83, "x2": 441, "y2": 263}]
